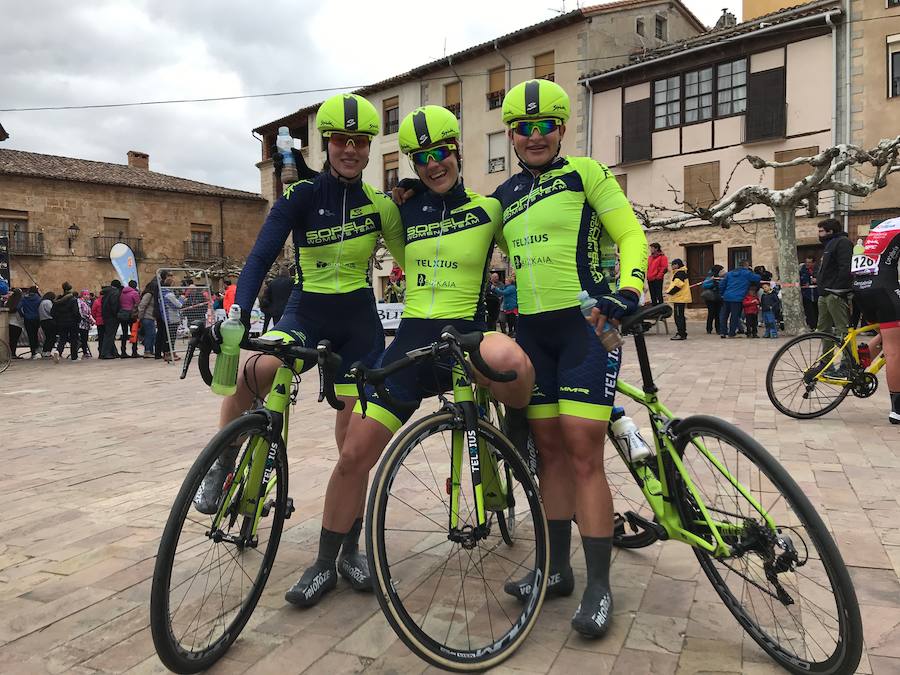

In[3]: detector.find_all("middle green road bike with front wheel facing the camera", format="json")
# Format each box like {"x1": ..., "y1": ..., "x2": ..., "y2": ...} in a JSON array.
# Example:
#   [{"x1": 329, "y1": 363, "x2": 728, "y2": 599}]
[{"x1": 351, "y1": 326, "x2": 549, "y2": 672}]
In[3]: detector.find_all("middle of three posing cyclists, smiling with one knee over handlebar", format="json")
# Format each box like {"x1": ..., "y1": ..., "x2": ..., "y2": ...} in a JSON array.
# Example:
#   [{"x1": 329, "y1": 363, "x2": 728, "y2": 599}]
[{"x1": 288, "y1": 106, "x2": 534, "y2": 605}]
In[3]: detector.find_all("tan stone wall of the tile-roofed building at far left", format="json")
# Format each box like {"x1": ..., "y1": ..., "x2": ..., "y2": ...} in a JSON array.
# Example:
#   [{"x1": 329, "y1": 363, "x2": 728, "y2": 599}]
[{"x1": 0, "y1": 176, "x2": 268, "y2": 290}]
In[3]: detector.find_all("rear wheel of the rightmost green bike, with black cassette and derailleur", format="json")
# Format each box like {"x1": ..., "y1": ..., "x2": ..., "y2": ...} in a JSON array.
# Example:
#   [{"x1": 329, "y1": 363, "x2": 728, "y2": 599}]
[{"x1": 667, "y1": 415, "x2": 862, "y2": 674}]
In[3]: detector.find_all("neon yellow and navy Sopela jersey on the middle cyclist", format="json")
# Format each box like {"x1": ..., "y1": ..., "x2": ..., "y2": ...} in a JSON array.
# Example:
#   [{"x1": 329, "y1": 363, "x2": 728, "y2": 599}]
[{"x1": 400, "y1": 182, "x2": 505, "y2": 319}]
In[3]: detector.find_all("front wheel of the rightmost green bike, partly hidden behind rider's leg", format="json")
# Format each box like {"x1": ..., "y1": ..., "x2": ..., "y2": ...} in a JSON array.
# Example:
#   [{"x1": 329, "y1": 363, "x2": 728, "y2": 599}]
[{"x1": 603, "y1": 430, "x2": 659, "y2": 548}]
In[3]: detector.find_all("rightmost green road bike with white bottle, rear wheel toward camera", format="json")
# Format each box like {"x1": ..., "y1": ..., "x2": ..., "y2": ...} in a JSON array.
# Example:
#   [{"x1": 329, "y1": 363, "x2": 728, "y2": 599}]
[{"x1": 605, "y1": 305, "x2": 863, "y2": 674}]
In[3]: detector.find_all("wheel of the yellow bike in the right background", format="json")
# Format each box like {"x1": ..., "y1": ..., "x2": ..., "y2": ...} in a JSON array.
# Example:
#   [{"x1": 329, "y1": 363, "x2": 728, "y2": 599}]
[{"x1": 766, "y1": 333, "x2": 853, "y2": 420}]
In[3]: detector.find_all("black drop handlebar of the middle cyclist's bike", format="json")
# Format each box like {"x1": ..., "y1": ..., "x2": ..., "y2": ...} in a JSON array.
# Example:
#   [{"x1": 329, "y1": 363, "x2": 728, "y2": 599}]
[{"x1": 350, "y1": 325, "x2": 516, "y2": 416}]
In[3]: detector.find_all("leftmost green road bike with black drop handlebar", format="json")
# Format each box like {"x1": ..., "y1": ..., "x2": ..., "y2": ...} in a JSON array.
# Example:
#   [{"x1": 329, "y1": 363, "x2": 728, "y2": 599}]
[{"x1": 150, "y1": 325, "x2": 343, "y2": 673}]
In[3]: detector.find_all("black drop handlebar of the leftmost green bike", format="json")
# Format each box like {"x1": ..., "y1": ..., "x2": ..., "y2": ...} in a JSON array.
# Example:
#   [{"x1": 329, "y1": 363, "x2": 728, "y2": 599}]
[{"x1": 181, "y1": 321, "x2": 344, "y2": 410}]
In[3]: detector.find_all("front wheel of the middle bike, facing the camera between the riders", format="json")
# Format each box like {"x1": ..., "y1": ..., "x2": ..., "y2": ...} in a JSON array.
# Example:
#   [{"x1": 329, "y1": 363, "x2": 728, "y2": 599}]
[{"x1": 366, "y1": 412, "x2": 548, "y2": 672}]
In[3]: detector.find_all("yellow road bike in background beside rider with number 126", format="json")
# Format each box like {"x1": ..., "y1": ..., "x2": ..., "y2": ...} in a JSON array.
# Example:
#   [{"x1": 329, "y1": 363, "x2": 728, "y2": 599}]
[{"x1": 766, "y1": 324, "x2": 885, "y2": 419}]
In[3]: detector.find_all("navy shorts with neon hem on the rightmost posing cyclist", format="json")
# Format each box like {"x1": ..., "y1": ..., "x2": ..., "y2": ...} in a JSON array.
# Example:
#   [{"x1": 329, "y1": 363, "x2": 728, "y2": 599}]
[{"x1": 516, "y1": 307, "x2": 622, "y2": 421}]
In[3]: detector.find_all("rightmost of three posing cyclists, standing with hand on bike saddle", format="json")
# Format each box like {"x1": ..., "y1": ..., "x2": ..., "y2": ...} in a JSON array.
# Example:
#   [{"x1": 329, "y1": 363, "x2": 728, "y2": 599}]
[{"x1": 494, "y1": 80, "x2": 648, "y2": 637}]
